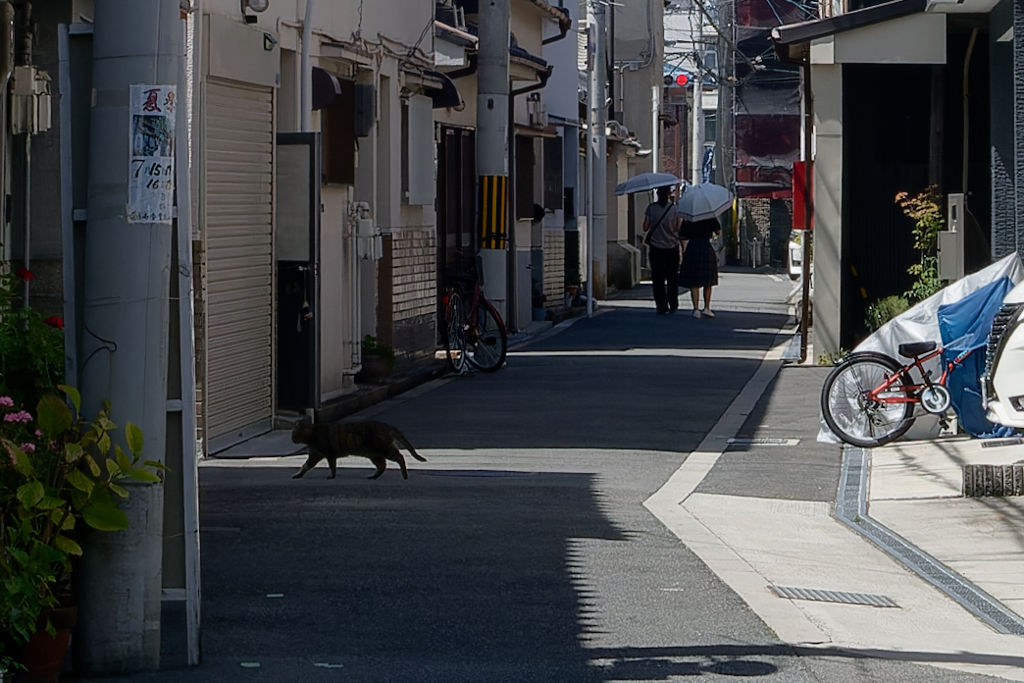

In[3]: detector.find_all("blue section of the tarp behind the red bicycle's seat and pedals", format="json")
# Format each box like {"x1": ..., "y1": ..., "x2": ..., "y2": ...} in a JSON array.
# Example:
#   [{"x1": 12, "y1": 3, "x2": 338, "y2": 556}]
[{"x1": 937, "y1": 278, "x2": 1014, "y2": 438}]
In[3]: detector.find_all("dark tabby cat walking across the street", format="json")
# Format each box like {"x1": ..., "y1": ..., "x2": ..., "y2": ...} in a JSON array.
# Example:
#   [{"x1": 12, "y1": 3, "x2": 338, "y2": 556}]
[{"x1": 292, "y1": 419, "x2": 427, "y2": 479}]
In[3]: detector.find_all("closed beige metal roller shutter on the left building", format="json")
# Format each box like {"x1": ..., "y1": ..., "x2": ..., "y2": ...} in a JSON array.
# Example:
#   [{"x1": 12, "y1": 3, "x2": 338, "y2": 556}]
[{"x1": 205, "y1": 81, "x2": 273, "y2": 452}]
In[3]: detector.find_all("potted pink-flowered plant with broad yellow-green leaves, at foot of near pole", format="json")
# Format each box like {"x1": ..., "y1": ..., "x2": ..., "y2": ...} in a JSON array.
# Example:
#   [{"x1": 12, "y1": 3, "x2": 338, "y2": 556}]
[{"x1": 0, "y1": 386, "x2": 163, "y2": 681}]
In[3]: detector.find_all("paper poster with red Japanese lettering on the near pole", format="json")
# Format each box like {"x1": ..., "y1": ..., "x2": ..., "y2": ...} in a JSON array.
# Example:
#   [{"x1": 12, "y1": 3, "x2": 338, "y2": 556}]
[{"x1": 128, "y1": 85, "x2": 177, "y2": 224}]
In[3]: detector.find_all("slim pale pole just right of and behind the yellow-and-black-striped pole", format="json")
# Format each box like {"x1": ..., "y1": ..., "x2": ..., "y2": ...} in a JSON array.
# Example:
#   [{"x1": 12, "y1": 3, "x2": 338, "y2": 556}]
[{"x1": 587, "y1": 0, "x2": 608, "y2": 299}]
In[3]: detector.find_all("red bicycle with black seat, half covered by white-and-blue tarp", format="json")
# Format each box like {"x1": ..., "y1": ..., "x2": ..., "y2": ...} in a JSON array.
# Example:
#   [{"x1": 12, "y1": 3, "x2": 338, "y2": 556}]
[{"x1": 821, "y1": 341, "x2": 973, "y2": 449}]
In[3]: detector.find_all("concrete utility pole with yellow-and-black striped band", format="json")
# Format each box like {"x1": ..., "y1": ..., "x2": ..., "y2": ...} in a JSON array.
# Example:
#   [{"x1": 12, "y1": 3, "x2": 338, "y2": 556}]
[{"x1": 476, "y1": 0, "x2": 515, "y2": 319}]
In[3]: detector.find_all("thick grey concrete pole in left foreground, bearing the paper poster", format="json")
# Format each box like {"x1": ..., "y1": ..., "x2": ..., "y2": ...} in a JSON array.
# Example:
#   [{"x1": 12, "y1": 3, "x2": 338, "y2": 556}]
[{"x1": 75, "y1": 0, "x2": 185, "y2": 674}]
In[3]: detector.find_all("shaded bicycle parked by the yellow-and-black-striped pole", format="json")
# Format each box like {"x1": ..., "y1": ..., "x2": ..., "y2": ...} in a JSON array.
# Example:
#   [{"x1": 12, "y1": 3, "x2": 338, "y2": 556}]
[{"x1": 441, "y1": 272, "x2": 509, "y2": 374}]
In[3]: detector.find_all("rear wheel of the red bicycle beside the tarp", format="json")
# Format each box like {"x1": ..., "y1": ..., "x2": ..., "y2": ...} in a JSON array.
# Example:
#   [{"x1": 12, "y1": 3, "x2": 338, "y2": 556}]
[{"x1": 821, "y1": 352, "x2": 913, "y2": 449}]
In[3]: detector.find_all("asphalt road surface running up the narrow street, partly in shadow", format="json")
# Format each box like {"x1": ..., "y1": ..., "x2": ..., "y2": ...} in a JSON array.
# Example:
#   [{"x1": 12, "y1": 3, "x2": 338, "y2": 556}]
[{"x1": 77, "y1": 275, "x2": 1007, "y2": 683}]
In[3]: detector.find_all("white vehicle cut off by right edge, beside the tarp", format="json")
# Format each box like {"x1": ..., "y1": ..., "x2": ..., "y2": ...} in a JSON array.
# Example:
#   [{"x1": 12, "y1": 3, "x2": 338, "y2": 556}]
[{"x1": 981, "y1": 283, "x2": 1024, "y2": 429}]
